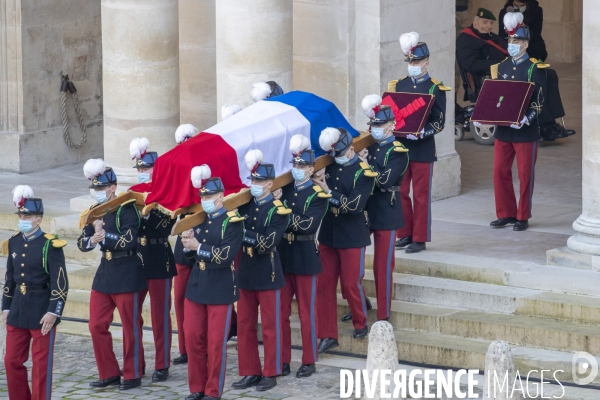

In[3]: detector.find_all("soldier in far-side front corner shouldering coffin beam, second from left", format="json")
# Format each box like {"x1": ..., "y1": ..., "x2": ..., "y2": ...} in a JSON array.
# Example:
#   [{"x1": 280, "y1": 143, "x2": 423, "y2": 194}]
[{"x1": 77, "y1": 159, "x2": 148, "y2": 390}]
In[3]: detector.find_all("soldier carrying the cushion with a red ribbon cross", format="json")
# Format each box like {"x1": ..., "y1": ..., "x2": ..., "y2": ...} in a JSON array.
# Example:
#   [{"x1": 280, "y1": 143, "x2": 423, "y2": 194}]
[{"x1": 388, "y1": 32, "x2": 450, "y2": 253}]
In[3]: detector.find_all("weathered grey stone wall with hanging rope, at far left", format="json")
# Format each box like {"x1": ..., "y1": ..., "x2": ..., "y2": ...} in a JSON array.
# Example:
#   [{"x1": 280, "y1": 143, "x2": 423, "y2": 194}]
[{"x1": 0, "y1": 0, "x2": 103, "y2": 173}]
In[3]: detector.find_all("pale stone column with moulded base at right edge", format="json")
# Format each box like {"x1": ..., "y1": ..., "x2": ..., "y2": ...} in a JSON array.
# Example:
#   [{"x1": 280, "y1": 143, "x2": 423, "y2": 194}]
[{"x1": 567, "y1": 0, "x2": 600, "y2": 255}]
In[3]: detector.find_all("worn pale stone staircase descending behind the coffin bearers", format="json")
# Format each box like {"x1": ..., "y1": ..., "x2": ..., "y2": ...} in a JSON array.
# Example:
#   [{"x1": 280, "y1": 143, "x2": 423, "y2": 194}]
[{"x1": 0, "y1": 206, "x2": 600, "y2": 398}]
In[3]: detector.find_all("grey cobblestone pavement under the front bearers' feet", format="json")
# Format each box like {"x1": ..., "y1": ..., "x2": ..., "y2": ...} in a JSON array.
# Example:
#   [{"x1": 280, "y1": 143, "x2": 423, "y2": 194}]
[{"x1": 0, "y1": 334, "x2": 340, "y2": 400}]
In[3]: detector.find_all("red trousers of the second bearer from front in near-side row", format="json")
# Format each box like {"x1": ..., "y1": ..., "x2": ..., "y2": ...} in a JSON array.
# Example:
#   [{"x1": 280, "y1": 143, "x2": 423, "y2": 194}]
[{"x1": 238, "y1": 289, "x2": 281, "y2": 377}]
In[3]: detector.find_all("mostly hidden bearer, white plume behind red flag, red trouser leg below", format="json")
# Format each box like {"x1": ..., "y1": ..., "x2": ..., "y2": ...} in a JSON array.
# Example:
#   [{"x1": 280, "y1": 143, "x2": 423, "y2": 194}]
[{"x1": 173, "y1": 124, "x2": 198, "y2": 365}]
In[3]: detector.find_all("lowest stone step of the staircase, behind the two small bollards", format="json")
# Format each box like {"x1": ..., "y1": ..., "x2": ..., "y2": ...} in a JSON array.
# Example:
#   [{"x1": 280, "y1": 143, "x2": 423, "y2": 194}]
[{"x1": 270, "y1": 317, "x2": 600, "y2": 385}]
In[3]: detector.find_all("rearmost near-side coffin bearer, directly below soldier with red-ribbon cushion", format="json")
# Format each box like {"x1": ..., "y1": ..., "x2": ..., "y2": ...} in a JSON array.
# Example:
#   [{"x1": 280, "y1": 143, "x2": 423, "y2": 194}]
[{"x1": 362, "y1": 94, "x2": 408, "y2": 321}]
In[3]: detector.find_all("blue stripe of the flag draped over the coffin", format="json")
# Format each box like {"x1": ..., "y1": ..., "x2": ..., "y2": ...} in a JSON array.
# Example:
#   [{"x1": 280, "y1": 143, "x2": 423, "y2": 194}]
[{"x1": 266, "y1": 90, "x2": 360, "y2": 157}]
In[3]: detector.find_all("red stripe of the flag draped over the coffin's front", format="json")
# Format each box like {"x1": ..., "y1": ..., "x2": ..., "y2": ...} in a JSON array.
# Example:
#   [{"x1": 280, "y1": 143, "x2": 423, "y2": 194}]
[{"x1": 141, "y1": 132, "x2": 246, "y2": 210}]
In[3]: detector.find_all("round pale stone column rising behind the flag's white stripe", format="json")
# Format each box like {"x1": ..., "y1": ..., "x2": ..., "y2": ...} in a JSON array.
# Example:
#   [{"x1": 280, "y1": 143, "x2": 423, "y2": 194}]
[{"x1": 216, "y1": 0, "x2": 293, "y2": 110}]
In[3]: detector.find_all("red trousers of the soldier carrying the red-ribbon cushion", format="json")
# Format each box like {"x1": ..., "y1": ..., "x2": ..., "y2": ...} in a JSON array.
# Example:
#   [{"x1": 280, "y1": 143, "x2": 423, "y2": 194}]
[{"x1": 396, "y1": 161, "x2": 433, "y2": 242}]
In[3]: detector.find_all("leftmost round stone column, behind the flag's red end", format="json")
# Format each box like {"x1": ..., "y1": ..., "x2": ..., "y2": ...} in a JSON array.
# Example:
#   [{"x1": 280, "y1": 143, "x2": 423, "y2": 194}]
[{"x1": 102, "y1": 0, "x2": 179, "y2": 182}]
